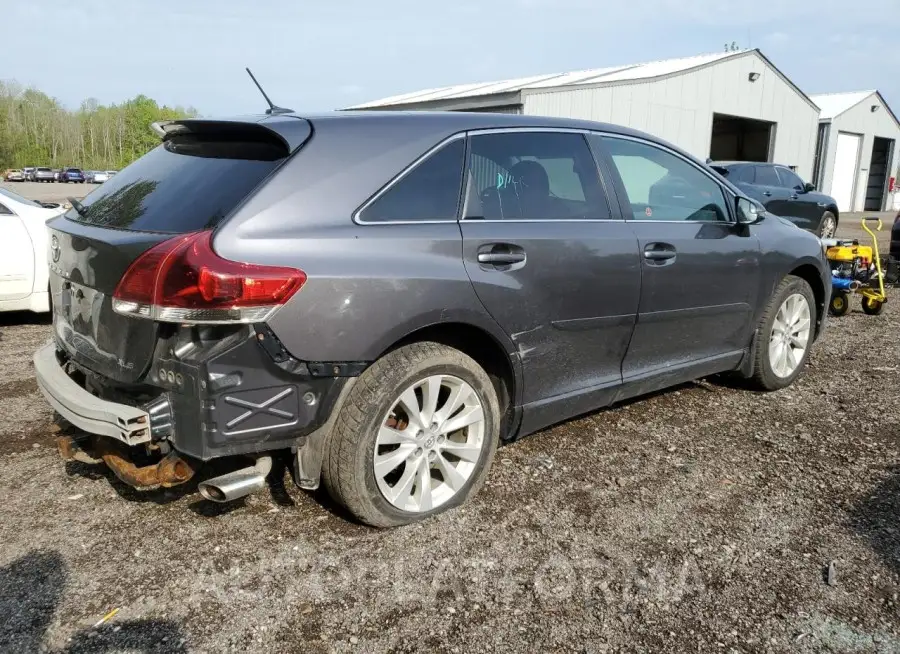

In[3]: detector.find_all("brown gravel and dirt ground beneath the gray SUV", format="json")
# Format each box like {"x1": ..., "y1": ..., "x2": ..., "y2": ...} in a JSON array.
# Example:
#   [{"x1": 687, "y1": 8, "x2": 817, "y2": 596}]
[{"x1": 0, "y1": 201, "x2": 900, "y2": 652}]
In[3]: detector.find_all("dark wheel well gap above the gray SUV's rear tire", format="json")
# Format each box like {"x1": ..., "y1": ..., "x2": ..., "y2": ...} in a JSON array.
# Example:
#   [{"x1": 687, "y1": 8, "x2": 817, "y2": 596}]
[{"x1": 387, "y1": 323, "x2": 516, "y2": 437}]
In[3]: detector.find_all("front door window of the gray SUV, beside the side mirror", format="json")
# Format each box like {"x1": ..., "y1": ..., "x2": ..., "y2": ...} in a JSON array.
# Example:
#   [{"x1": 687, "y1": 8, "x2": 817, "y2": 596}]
[{"x1": 600, "y1": 137, "x2": 729, "y2": 222}]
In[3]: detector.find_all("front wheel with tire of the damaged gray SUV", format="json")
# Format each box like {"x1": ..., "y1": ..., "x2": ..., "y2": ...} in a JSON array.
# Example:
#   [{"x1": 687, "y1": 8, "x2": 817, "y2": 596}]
[{"x1": 752, "y1": 275, "x2": 816, "y2": 391}]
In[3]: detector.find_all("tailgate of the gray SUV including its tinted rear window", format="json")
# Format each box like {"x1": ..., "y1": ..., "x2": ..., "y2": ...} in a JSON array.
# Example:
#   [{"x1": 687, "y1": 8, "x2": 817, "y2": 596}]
[{"x1": 48, "y1": 121, "x2": 309, "y2": 383}]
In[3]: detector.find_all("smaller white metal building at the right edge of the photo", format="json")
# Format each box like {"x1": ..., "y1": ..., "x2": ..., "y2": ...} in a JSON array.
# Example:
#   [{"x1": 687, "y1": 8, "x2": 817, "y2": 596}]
[{"x1": 812, "y1": 91, "x2": 900, "y2": 211}]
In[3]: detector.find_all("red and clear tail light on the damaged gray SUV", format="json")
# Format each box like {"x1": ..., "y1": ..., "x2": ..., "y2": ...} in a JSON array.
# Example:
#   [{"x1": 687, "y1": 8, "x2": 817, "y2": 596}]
[{"x1": 113, "y1": 231, "x2": 306, "y2": 323}]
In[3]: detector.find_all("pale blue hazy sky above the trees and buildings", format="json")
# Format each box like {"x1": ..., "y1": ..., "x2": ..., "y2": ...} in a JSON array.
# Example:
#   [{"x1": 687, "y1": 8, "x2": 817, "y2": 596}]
[{"x1": 0, "y1": 0, "x2": 900, "y2": 116}]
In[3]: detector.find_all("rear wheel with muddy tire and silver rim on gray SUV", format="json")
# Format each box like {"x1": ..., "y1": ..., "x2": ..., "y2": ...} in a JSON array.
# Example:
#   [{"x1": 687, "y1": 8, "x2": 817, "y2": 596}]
[{"x1": 322, "y1": 342, "x2": 501, "y2": 527}]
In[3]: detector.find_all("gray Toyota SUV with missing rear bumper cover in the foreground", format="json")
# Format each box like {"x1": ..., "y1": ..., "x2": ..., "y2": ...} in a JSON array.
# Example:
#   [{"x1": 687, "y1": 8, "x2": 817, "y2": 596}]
[{"x1": 34, "y1": 113, "x2": 831, "y2": 526}]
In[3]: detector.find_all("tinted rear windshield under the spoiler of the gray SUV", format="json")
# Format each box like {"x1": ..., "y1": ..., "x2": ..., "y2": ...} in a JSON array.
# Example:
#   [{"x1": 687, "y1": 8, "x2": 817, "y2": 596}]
[{"x1": 66, "y1": 130, "x2": 290, "y2": 234}]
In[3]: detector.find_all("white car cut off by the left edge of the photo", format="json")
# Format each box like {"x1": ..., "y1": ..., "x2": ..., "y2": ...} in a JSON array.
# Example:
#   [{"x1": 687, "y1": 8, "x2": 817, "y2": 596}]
[{"x1": 0, "y1": 188, "x2": 65, "y2": 313}]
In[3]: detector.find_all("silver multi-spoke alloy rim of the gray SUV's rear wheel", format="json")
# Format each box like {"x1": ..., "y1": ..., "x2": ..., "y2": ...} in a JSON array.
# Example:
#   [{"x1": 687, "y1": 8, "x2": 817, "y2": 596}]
[{"x1": 373, "y1": 375, "x2": 485, "y2": 513}]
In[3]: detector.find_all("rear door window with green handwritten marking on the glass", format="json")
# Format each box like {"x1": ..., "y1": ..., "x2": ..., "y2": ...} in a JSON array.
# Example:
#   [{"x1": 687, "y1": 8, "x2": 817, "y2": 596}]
[{"x1": 466, "y1": 130, "x2": 610, "y2": 220}]
